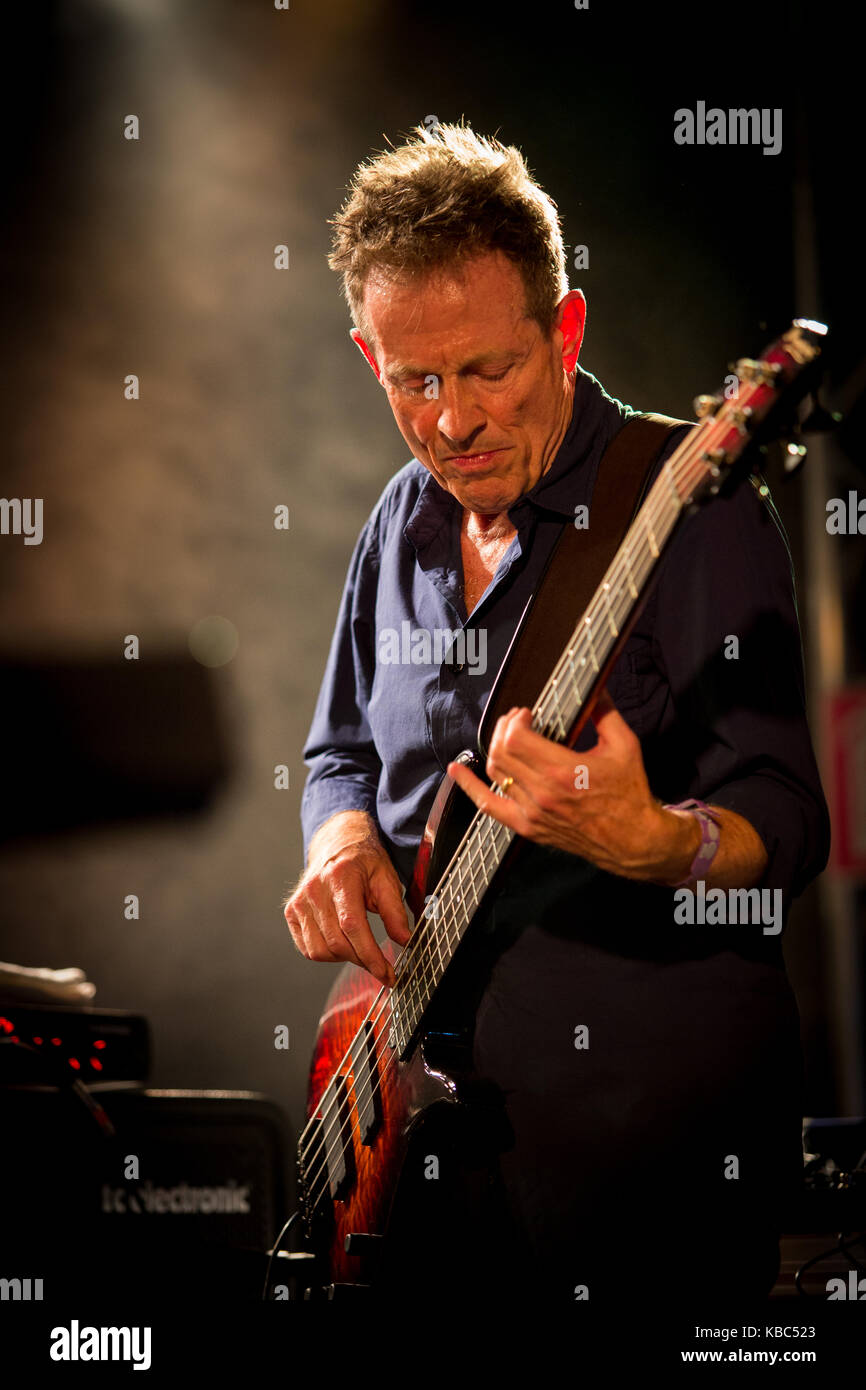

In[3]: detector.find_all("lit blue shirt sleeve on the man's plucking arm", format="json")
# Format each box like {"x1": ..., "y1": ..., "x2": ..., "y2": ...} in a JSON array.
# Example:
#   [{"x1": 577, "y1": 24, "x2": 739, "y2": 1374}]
[{"x1": 300, "y1": 513, "x2": 382, "y2": 860}]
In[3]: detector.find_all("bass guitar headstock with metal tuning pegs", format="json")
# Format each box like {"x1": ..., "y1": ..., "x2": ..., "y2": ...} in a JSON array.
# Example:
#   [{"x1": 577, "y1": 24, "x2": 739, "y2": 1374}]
[{"x1": 689, "y1": 318, "x2": 827, "y2": 502}]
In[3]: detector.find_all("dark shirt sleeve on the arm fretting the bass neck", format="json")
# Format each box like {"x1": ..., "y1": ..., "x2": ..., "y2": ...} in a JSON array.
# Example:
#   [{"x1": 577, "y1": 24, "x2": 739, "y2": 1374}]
[{"x1": 653, "y1": 455, "x2": 830, "y2": 913}]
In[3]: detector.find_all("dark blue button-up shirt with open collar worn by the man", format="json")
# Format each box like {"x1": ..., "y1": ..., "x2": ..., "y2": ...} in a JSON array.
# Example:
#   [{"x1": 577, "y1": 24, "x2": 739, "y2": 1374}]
[{"x1": 302, "y1": 367, "x2": 828, "y2": 920}]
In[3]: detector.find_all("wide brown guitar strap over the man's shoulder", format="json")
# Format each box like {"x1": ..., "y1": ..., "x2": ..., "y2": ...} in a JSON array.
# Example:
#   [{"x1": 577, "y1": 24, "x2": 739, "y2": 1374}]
[{"x1": 478, "y1": 411, "x2": 688, "y2": 756}]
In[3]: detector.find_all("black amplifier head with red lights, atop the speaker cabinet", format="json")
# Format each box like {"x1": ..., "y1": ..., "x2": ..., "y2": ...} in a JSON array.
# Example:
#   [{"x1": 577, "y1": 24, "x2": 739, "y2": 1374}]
[{"x1": 0, "y1": 999, "x2": 150, "y2": 1087}]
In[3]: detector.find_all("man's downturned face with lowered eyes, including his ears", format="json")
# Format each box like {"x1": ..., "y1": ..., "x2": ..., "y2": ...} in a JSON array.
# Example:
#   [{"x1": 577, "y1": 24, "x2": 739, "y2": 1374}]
[{"x1": 352, "y1": 252, "x2": 585, "y2": 516}]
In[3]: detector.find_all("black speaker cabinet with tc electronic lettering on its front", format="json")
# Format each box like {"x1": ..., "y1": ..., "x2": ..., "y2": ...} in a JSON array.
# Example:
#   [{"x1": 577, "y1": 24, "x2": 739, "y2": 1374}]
[{"x1": 0, "y1": 1087, "x2": 293, "y2": 1302}]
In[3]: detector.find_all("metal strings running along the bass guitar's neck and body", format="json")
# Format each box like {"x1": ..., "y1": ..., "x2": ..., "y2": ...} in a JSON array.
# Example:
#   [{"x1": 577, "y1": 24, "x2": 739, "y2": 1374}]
[{"x1": 299, "y1": 384, "x2": 770, "y2": 1205}]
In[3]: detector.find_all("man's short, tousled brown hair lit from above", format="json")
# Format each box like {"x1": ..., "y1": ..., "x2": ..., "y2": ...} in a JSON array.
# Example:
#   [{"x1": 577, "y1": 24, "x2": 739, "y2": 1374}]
[{"x1": 328, "y1": 124, "x2": 569, "y2": 346}]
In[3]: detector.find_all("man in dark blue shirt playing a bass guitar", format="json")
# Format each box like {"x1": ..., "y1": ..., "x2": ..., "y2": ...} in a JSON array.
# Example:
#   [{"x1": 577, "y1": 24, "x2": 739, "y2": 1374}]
[{"x1": 285, "y1": 125, "x2": 828, "y2": 1304}]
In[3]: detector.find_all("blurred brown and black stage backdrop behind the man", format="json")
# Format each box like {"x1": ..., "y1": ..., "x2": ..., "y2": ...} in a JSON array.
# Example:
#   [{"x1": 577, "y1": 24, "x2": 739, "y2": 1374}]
[{"x1": 0, "y1": 0, "x2": 865, "y2": 1195}]
